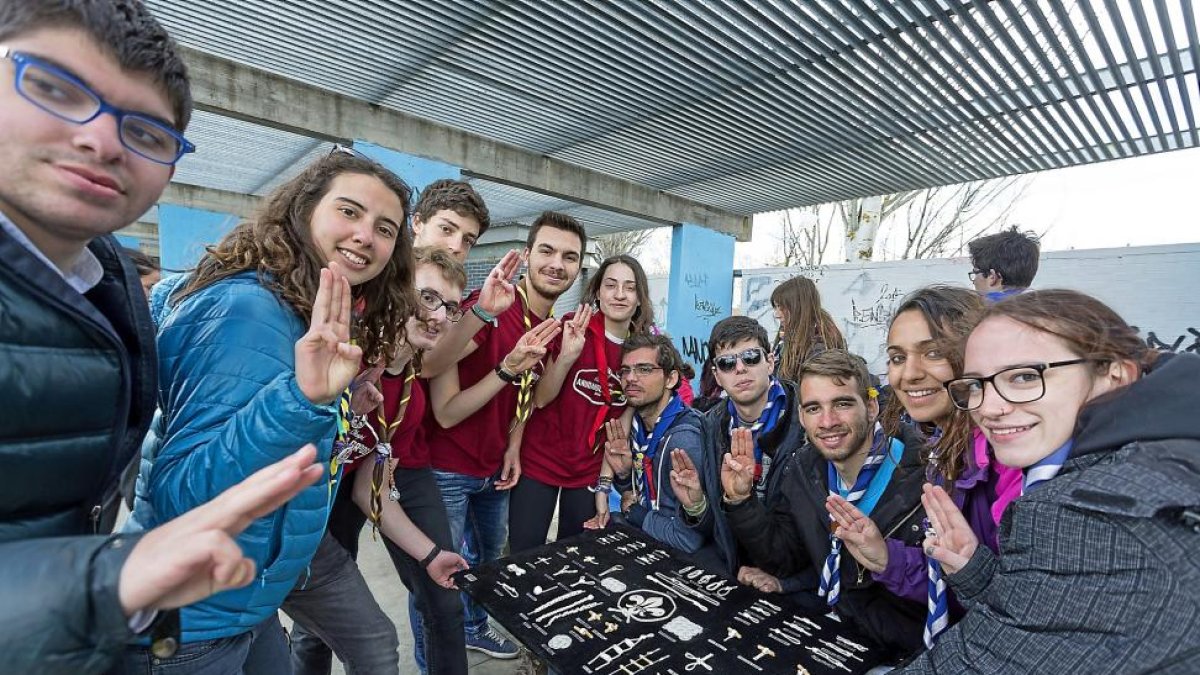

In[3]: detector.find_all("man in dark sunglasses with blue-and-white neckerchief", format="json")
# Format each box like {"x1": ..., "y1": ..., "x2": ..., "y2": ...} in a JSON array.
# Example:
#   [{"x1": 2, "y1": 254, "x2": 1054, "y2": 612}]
[{"x1": 672, "y1": 316, "x2": 816, "y2": 578}]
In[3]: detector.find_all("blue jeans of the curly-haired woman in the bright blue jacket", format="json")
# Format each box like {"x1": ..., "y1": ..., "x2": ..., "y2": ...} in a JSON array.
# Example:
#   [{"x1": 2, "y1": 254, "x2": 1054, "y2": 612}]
[{"x1": 113, "y1": 616, "x2": 292, "y2": 675}]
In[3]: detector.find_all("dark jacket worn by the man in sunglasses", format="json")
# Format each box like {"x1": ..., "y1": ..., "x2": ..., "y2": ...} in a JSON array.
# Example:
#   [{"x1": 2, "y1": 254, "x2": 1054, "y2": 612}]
[{"x1": 688, "y1": 380, "x2": 816, "y2": 576}]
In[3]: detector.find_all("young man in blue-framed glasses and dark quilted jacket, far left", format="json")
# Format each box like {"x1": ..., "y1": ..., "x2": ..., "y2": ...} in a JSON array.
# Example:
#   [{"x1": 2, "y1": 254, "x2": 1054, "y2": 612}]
[{"x1": 0, "y1": 0, "x2": 322, "y2": 673}]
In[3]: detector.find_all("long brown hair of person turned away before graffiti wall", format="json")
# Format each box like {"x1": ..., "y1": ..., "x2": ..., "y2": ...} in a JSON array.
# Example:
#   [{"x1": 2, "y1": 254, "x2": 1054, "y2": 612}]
[{"x1": 770, "y1": 276, "x2": 846, "y2": 382}]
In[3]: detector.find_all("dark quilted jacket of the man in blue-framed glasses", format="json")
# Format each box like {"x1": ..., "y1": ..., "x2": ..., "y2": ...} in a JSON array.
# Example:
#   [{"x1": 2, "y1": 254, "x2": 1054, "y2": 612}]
[{"x1": 0, "y1": 231, "x2": 157, "y2": 673}]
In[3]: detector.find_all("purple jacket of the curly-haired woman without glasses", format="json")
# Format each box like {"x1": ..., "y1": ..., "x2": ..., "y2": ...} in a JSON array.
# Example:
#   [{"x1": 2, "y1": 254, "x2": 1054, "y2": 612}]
[{"x1": 871, "y1": 429, "x2": 1021, "y2": 610}]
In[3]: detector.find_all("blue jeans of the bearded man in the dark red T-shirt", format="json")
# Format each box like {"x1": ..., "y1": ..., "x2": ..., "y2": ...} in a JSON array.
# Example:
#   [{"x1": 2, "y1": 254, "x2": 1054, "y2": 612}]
[{"x1": 409, "y1": 471, "x2": 509, "y2": 673}]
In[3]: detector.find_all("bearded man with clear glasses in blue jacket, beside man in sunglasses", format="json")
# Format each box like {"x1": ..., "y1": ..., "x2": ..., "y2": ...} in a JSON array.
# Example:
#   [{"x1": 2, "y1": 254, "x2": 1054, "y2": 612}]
[{"x1": 605, "y1": 334, "x2": 704, "y2": 554}]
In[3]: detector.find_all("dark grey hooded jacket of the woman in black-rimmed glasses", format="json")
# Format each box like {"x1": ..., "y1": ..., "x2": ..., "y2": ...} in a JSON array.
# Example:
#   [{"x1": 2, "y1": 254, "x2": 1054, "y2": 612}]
[{"x1": 898, "y1": 354, "x2": 1200, "y2": 675}]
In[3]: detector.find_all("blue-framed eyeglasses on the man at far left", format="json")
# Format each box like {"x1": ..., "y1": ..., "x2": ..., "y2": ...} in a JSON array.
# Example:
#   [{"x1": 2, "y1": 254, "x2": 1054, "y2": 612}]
[{"x1": 0, "y1": 46, "x2": 196, "y2": 166}]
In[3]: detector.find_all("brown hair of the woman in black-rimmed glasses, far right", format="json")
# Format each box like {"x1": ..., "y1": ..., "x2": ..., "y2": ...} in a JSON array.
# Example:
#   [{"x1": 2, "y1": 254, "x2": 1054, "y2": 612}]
[{"x1": 980, "y1": 288, "x2": 1160, "y2": 372}]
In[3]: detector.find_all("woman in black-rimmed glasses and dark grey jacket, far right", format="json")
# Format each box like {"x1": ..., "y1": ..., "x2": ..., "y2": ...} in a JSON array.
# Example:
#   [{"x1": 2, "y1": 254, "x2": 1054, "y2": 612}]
[{"x1": 898, "y1": 291, "x2": 1200, "y2": 674}]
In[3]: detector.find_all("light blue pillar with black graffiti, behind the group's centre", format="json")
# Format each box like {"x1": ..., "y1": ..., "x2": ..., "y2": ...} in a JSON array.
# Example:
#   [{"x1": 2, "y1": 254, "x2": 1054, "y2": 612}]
[{"x1": 660, "y1": 223, "x2": 733, "y2": 374}]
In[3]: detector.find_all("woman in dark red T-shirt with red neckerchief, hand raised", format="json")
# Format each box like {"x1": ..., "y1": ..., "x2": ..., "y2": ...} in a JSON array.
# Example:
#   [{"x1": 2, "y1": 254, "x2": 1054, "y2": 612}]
[{"x1": 509, "y1": 255, "x2": 654, "y2": 552}]
